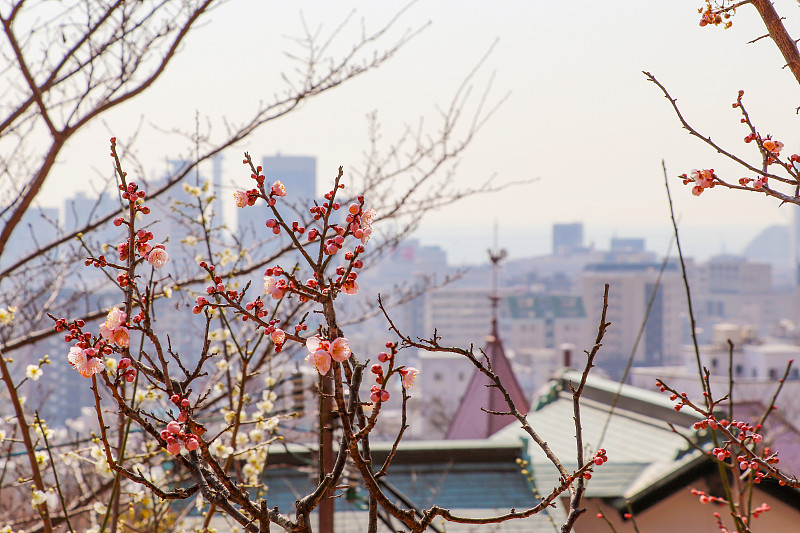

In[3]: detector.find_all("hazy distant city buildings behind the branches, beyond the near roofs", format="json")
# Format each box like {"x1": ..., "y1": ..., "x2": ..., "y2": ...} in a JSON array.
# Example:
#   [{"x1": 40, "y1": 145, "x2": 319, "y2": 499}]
[{"x1": 11, "y1": 154, "x2": 800, "y2": 439}]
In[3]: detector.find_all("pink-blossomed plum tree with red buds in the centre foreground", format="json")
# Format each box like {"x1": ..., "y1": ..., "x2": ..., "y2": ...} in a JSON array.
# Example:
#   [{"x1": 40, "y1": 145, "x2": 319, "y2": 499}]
[{"x1": 0, "y1": 138, "x2": 608, "y2": 532}]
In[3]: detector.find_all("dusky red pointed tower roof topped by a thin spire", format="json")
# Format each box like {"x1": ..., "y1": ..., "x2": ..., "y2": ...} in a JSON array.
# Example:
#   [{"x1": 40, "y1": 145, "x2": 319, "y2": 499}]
[{"x1": 446, "y1": 239, "x2": 529, "y2": 439}]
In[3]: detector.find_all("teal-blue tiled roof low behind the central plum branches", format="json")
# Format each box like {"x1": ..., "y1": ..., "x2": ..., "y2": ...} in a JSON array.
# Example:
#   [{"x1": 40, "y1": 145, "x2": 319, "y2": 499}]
[{"x1": 184, "y1": 439, "x2": 565, "y2": 533}]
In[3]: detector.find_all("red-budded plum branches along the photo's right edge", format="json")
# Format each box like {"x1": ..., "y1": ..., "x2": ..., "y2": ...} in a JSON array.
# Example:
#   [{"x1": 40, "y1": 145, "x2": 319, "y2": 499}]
[{"x1": 644, "y1": 0, "x2": 800, "y2": 533}]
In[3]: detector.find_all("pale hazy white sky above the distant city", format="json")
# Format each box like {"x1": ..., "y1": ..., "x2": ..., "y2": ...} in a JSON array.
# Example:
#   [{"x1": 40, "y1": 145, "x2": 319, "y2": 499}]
[{"x1": 37, "y1": 0, "x2": 800, "y2": 261}]
